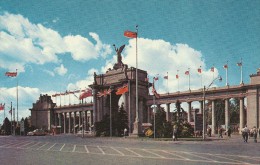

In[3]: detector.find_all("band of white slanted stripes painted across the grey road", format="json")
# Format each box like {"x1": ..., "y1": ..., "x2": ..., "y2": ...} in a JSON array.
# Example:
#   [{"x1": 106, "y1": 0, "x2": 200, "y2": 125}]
[{"x1": 0, "y1": 140, "x2": 260, "y2": 164}]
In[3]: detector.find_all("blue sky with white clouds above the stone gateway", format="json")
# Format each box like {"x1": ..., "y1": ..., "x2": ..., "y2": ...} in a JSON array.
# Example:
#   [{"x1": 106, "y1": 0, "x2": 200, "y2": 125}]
[{"x1": 0, "y1": 0, "x2": 260, "y2": 121}]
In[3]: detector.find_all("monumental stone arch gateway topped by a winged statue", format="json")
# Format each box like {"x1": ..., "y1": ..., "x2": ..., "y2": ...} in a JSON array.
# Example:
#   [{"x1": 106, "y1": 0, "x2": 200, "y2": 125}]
[{"x1": 89, "y1": 45, "x2": 150, "y2": 134}]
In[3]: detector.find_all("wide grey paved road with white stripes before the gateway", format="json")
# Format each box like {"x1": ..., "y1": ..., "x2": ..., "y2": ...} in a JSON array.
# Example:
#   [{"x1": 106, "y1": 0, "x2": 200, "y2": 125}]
[{"x1": 0, "y1": 135, "x2": 260, "y2": 165}]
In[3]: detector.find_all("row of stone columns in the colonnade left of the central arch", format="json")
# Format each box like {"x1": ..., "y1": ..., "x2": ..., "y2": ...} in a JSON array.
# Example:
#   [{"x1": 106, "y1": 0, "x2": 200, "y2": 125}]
[{"x1": 54, "y1": 111, "x2": 93, "y2": 134}]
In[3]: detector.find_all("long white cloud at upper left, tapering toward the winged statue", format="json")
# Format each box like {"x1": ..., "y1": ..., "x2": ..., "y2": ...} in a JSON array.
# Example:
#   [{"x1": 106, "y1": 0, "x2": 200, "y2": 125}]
[{"x1": 0, "y1": 13, "x2": 111, "y2": 72}]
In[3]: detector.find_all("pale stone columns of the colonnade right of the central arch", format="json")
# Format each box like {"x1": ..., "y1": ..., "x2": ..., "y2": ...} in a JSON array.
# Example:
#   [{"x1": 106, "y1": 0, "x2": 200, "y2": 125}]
[{"x1": 147, "y1": 97, "x2": 245, "y2": 133}]
